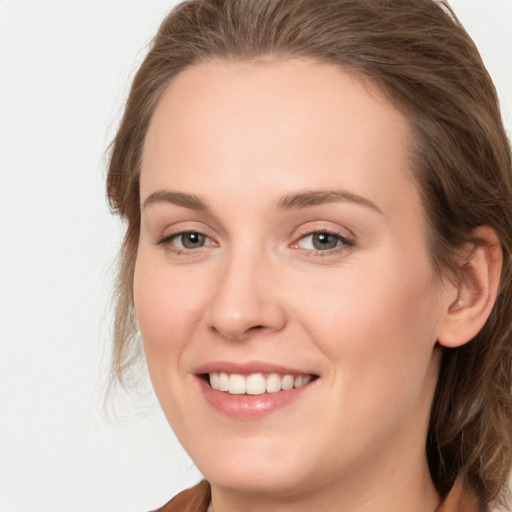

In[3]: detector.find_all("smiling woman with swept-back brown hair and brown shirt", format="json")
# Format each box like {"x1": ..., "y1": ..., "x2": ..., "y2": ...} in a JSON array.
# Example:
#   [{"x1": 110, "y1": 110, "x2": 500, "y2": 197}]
[{"x1": 108, "y1": 0, "x2": 512, "y2": 512}]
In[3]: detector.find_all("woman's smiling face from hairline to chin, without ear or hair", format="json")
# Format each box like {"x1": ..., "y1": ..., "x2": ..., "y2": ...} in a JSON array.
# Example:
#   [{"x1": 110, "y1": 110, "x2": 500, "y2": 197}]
[{"x1": 135, "y1": 60, "x2": 446, "y2": 495}]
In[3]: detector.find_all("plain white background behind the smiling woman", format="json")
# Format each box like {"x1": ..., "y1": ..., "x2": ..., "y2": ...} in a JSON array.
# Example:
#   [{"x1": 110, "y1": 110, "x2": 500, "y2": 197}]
[{"x1": 0, "y1": 0, "x2": 512, "y2": 512}]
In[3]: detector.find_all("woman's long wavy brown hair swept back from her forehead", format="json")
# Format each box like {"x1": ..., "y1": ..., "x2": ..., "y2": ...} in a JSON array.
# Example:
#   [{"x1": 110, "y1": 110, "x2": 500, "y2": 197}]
[{"x1": 107, "y1": 0, "x2": 512, "y2": 505}]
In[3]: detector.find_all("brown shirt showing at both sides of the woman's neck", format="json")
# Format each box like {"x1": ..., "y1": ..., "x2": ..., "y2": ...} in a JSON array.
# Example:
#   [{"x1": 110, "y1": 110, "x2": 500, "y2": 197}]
[{"x1": 154, "y1": 480, "x2": 485, "y2": 512}]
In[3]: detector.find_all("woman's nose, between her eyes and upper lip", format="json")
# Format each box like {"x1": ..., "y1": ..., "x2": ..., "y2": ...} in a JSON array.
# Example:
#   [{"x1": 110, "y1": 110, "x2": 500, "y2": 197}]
[{"x1": 207, "y1": 247, "x2": 286, "y2": 340}]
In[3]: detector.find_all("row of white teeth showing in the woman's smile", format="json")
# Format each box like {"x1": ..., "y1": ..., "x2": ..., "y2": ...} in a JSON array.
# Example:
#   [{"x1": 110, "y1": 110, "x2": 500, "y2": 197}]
[{"x1": 209, "y1": 372, "x2": 313, "y2": 395}]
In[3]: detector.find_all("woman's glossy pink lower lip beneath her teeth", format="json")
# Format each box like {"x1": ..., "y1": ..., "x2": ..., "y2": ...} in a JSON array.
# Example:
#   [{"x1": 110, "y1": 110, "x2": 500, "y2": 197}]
[{"x1": 198, "y1": 378, "x2": 316, "y2": 419}]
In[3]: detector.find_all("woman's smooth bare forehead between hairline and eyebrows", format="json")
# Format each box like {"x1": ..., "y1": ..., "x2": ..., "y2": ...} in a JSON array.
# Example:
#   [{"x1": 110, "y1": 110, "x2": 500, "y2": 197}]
[{"x1": 141, "y1": 60, "x2": 412, "y2": 216}]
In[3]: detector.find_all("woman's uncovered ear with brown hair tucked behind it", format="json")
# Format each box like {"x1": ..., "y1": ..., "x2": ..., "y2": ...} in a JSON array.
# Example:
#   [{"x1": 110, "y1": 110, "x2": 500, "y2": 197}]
[{"x1": 437, "y1": 226, "x2": 503, "y2": 348}]
